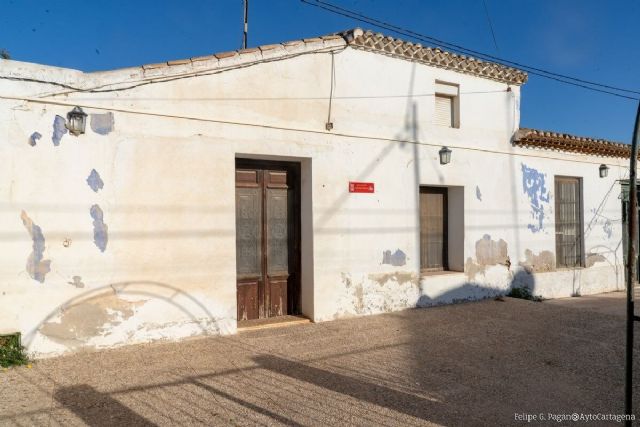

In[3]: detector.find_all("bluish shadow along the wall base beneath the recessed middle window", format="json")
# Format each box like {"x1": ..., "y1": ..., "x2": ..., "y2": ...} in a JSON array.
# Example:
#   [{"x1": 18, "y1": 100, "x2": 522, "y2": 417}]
[{"x1": 416, "y1": 269, "x2": 535, "y2": 307}]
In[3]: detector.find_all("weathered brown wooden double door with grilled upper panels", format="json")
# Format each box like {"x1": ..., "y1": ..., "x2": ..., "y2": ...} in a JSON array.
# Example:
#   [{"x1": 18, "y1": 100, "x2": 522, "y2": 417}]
[{"x1": 236, "y1": 159, "x2": 300, "y2": 321}]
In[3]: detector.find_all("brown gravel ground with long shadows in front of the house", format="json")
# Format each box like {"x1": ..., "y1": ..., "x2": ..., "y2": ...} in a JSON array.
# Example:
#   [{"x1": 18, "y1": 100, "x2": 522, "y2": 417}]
[{"x1": 0, "y1": 293, "x2": 640, "y2": 426}]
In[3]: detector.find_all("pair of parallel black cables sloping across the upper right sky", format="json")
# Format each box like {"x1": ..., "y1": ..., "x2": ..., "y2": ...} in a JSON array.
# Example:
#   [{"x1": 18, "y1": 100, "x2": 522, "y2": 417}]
[{"x1": 300, "y1": 0, "x2": 640, "y2": 101}]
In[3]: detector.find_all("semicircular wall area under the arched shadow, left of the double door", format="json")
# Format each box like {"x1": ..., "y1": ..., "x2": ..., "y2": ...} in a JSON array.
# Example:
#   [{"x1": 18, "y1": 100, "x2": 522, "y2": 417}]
[{"x1": 25, "y1": 281, "x2": 230, "y2": 354}]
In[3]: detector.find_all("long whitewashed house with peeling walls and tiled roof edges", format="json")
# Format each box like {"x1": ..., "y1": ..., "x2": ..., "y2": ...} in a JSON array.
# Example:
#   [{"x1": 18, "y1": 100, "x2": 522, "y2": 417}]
[{"x1": 0, "y1": 29, "x2": 629, "y2": 356}]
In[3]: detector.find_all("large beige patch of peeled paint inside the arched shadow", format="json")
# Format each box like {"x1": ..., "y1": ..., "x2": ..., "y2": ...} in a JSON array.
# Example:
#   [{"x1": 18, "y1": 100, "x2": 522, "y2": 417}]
[{"x1": 39, "y1": 295, "x2": 143, "y2": 347}]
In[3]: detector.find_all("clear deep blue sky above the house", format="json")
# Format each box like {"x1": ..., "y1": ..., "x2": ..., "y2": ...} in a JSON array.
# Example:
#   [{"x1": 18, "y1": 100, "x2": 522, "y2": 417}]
[{"x1": 0, "y1": 0, "x2": 640, "y2": 142}]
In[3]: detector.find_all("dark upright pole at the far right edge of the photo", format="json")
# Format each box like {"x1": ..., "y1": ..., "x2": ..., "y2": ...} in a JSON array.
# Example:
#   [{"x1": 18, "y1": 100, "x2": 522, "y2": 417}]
[{"x1": 624, "y1": 103, "x2": 640, "y2": 426}]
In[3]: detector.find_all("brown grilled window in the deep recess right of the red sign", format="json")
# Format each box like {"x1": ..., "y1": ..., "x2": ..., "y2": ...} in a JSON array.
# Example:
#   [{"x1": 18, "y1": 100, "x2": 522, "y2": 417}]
[{"x1": 420, "y1": 187, "x2": 449, "y2": 271}]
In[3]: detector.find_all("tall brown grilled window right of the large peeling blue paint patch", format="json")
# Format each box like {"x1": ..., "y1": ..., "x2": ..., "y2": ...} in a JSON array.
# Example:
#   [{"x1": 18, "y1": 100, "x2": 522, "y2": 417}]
[{"x1": 555, "y1": 177, "x2": 584, "y2": 267}]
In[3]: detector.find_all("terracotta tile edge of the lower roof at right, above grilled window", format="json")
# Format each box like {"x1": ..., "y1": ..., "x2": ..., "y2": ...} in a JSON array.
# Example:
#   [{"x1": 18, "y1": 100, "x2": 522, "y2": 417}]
[{"x1": 513, "y1": 128, "x2": 631, "y2": 159}]
